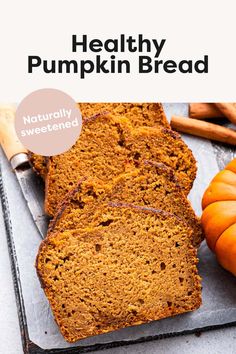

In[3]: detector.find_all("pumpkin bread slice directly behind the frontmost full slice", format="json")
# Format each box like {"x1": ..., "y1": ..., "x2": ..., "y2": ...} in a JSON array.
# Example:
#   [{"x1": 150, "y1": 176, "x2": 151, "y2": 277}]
[{"x1": 49, "y1": 161, "x2": 203, "y2": 246}]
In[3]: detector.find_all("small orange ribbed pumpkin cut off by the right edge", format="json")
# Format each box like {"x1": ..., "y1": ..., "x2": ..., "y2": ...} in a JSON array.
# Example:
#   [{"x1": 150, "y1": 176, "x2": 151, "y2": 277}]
[{"x1": 201, "y1": 159, "x2": 236, "y2": 276}]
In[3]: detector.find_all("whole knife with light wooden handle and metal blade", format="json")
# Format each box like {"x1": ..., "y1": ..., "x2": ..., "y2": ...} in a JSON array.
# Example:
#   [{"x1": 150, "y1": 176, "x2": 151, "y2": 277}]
[{"x1": 0, "y1": 106, "x2": 49, "y2": 238}]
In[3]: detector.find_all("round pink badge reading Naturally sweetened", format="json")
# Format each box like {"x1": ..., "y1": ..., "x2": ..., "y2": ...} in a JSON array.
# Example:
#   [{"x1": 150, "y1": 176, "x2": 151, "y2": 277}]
[{"x1": 15, "y1": 89, "x2": 82, "y2": 156}]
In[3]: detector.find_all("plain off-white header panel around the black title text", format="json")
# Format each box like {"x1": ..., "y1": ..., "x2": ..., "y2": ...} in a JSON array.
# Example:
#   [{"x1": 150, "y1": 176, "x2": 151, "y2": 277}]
[{"x1": 0, "y1": 0, "x2": 236, "y2": 102}]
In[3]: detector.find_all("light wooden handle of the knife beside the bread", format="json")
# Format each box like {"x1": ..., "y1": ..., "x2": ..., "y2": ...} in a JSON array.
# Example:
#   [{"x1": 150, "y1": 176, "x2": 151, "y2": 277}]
[{"x1": 0, "y1": 106, "x2": 27, "y2": 161}]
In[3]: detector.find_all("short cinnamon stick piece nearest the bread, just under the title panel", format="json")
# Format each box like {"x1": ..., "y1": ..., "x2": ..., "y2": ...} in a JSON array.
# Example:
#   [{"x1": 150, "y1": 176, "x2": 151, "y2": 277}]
[{"x1": 189, "y1": 103, "x2": 224, "y2": 119}]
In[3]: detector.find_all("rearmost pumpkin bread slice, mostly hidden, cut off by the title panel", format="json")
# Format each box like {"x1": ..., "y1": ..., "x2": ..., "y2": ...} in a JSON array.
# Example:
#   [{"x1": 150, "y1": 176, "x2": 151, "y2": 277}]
[{"x1": 30, "y1": 103, "x2": 170, "y2": 178}]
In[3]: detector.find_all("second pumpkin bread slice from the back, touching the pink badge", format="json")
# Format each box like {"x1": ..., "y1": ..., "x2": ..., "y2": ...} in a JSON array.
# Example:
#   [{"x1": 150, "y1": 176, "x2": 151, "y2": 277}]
[{"x1": 46, "y1": 114, "x2": 196, "y2": 215}]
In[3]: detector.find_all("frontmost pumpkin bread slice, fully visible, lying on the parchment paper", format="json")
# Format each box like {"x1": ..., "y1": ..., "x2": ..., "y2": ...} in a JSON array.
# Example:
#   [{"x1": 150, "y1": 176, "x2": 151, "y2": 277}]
[{"x1": 37, "y1": 204, "x2": 201, "y2": 342}]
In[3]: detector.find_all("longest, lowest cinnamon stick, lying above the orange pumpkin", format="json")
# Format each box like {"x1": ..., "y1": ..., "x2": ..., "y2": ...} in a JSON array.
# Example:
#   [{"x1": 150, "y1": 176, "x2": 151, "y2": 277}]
[{"x1": 171, "y1": 116, "x2": 236, "y2": 145}]
